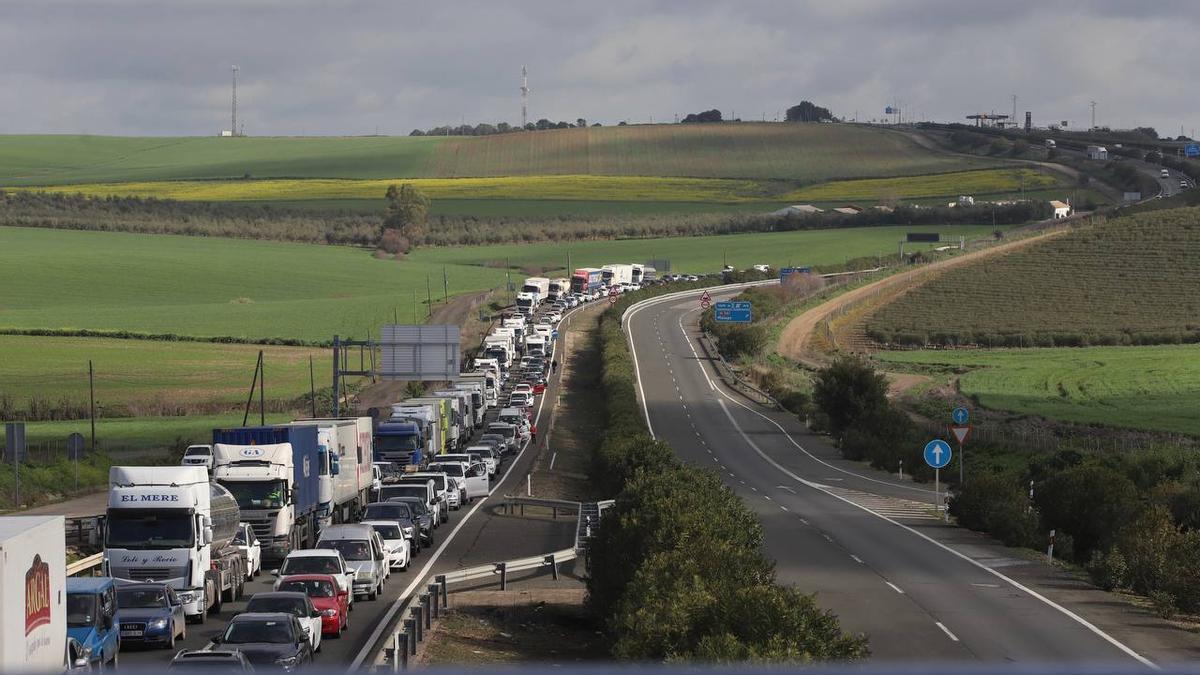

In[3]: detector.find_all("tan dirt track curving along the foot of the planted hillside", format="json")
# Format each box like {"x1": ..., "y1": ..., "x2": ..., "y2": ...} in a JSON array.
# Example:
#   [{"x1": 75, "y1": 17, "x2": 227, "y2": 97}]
[{"x1": 775, "y1": 225, "x2": 1066, "y2": 366}]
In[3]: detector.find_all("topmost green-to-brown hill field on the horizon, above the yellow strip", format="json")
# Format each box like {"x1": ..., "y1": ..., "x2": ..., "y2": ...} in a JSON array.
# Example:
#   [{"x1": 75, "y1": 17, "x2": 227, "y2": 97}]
[{"x1": 0, "y1": 124, "x2": 1000, "y2": 186}]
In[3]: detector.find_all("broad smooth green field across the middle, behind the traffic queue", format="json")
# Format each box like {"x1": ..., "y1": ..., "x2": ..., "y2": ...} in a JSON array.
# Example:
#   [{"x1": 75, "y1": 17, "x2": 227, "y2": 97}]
[{"x1": 0, "y1": 226, "x2": 990, "y2": 341}]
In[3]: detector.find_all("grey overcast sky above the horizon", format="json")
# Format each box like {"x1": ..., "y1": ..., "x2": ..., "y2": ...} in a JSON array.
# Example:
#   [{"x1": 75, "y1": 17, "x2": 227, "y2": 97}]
[{"x1": 0, "y1": 0, "x2": 1200, "y2": 138}]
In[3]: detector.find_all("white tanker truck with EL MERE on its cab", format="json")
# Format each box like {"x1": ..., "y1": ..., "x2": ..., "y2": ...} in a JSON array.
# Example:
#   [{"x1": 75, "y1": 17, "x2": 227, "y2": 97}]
[{"x1": 101, "y1": 468, "x2": 246, "y2": 623}]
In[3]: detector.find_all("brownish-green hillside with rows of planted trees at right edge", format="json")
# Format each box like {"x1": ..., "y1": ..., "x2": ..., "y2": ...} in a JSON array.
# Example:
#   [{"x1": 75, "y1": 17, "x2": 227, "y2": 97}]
[{"x1": 866, "y1": 208, "x2": 1200, "y2": 347}]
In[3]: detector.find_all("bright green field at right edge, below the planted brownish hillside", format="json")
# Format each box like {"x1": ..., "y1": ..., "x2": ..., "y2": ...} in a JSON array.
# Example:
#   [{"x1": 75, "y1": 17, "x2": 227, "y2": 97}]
[{"x1": 875, "y1": 345, "x2": 1200, "y2": 434}]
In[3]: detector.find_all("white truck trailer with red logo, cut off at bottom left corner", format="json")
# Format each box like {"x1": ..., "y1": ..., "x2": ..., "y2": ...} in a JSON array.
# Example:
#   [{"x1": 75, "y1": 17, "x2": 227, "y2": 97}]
[{"x1": 0, "y1": 514, "x2": 66, "y2": 673}]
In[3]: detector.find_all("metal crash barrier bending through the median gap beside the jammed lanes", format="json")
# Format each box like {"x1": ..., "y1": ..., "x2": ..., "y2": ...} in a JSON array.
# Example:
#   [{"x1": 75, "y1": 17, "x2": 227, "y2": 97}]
[{"x1": 384, "y1": 495, "x2": 614, "y2": 671}]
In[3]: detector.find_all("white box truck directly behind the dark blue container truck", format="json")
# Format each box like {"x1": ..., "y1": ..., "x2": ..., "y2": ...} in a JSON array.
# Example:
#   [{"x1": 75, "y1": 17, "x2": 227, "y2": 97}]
[{"x1": 290, "y1": 417, "x2": 372, "y2": 527}]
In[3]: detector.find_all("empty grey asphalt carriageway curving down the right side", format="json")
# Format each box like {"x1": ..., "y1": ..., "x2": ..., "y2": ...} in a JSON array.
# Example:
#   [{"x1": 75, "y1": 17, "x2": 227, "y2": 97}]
[{"x1": 625, "y1": 282, "x2": 1152, "y2": 667}]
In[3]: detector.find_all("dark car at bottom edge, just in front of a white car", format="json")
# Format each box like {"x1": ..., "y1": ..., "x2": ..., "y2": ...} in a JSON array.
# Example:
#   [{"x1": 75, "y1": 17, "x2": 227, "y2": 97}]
[{"x1": 209, "y1": 613, "x2": 312, "y2": 671}]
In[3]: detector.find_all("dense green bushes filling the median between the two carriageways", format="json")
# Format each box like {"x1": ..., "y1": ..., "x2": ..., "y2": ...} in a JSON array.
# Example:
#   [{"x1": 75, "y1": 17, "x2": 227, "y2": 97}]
[{"x1": 588, "y1": 288, "x2": 866, "y2": 663}]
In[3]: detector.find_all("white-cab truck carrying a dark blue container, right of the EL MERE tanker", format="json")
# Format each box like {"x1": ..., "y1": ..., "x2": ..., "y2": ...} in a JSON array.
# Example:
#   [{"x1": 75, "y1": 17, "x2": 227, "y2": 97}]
[{"x1": 212, "y1": 424, "x2": 328, "y2": 560}]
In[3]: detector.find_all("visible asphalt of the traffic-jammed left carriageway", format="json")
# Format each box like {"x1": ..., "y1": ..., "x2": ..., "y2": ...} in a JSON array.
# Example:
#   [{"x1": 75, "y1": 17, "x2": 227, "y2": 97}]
[{"x1": 120, "y1": 305, "x2": 587, "y2": 669}]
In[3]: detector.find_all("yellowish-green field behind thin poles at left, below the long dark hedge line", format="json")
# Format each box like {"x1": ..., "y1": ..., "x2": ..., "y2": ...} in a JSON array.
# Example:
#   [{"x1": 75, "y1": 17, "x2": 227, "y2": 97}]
[{"x1": 0, "y1": 335, "x2": 331, "y2": 408}]
